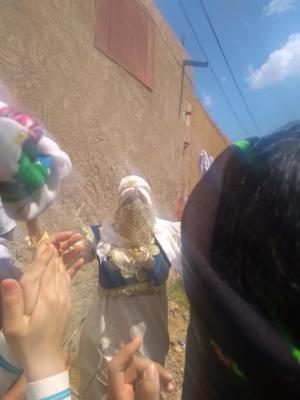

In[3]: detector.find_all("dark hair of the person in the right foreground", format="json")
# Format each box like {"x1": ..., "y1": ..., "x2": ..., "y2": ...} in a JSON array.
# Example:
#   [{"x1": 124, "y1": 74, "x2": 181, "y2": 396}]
[{"x1": 211, "y1": 126, "x2": 300, "y2": 343}]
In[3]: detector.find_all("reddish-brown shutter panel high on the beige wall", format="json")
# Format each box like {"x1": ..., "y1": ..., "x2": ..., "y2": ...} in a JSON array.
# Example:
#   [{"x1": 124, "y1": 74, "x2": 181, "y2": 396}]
[{"x1": 96, "y1": 0, "x2": 154, "y2": 89}]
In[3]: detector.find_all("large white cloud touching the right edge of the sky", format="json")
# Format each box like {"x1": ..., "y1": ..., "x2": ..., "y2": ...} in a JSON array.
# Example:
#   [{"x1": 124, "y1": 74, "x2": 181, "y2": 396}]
[{"x1": 246, "y1": 32, "x2": 300, "y2": 90}]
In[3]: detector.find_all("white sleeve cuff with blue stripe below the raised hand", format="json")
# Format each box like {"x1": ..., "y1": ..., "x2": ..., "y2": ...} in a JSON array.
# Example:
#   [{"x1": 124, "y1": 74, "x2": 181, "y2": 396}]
[{"x1": 26, "y1": 371, "x2": 71, "y2": 400}]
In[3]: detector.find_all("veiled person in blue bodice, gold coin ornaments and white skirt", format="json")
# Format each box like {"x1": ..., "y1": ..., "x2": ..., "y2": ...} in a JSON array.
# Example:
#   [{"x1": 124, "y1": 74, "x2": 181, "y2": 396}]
[{"x1": 79, "y1": 176, "x2": 180, "y2": 400}]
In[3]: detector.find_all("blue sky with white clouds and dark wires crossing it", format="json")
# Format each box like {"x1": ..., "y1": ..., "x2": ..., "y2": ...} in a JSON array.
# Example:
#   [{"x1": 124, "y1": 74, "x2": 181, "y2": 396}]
[{"x1": 155, "y1": 0, "x2": 300, "y2": 140}]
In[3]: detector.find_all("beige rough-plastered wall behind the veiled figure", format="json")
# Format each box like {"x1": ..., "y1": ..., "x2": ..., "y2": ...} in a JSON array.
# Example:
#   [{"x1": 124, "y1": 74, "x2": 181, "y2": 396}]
[{"x1": 0, "y1": 0, "x2": 227, "y2": 326}]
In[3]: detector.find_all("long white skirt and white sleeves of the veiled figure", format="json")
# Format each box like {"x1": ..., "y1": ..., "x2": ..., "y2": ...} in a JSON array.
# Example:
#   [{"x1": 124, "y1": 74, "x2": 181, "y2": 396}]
[{"x1": 79, "y1": 219, "x2": 181, "y2": 400}]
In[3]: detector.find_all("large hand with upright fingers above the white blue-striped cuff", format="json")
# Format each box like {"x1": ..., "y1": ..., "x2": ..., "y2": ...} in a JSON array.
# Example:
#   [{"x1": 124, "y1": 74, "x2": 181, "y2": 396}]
[{"x1": 1, "y1": 253, "x2": 70, "y2": 382}]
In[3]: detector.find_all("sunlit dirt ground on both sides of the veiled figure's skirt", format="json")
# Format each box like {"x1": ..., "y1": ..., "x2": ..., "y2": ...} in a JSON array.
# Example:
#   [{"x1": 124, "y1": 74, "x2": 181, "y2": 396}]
[{"x1": 68, "y1": 273, "x2": 189, "y2": 400}]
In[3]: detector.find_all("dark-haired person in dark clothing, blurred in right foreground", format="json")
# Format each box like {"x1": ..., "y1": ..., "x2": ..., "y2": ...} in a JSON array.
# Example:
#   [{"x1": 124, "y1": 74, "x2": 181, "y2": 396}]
[{"x1": 182, "y1": 125, "x2": 300, "y2": 400}]
